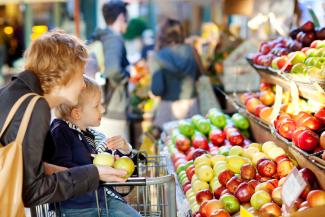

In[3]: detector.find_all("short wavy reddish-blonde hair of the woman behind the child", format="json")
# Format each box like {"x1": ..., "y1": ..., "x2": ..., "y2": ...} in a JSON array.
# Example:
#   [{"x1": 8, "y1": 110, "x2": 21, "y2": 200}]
[{"x1": 24, "y1": 30, "x2": 88, "y2": 93}]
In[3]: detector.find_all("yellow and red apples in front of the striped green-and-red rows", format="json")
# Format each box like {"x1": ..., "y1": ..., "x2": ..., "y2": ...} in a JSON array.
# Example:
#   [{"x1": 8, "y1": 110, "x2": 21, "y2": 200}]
[{"x1": 172, "y1": 142, "x2": 325, "y2": 217}]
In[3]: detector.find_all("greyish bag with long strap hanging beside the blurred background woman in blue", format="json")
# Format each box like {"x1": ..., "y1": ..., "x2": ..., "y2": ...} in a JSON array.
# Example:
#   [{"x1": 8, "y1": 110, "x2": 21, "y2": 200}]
[{"x1": 193, "y1": 48, "x2": 221, "y2": 115}]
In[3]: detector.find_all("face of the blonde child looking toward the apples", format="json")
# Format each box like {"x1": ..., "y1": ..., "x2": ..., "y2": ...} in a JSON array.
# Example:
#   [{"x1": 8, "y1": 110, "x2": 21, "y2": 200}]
[{"x1": 80, "y1": 93, "x2": 104, "y2": 128}]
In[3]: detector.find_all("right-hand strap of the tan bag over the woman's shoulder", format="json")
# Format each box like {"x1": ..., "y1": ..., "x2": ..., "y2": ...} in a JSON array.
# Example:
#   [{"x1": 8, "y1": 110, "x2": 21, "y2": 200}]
[{"x1": 16, "y1": 95, "x2": 41, "y2": 145}]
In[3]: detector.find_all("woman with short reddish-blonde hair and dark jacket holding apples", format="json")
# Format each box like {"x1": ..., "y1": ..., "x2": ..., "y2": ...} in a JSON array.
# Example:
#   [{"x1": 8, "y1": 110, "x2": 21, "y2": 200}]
[{"x1": 0, "y1": 31, "x2": 125, "y2": 207}]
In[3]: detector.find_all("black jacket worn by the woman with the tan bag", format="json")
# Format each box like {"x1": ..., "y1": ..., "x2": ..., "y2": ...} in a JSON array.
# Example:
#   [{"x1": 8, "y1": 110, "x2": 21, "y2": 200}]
[{"x1": 0, "y1": 71, "x2": 99, "y2": 207}]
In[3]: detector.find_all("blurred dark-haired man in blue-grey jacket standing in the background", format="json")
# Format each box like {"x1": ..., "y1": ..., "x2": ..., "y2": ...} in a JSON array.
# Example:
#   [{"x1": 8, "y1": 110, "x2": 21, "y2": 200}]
[{"x1": 92, "y1": 0, "x2": 130, "y2": 139}]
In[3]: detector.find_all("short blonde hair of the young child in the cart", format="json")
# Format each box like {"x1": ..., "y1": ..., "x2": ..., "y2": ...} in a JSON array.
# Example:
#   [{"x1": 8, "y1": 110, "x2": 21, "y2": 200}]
[{"x1": 54, "y1": 76, "x2": 101, "y2": 120}]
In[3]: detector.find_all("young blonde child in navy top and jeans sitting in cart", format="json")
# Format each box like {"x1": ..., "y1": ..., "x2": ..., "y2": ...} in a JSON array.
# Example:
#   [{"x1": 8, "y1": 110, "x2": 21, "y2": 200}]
[{"x1": 51, "y1": 77, "x2": 141, "y2": 217}]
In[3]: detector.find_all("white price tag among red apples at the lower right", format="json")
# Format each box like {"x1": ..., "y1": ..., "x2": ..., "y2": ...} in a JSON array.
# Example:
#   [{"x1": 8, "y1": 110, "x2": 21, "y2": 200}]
[{"x1": 281, "y1": 168, "x2": 307, "y2": 207}]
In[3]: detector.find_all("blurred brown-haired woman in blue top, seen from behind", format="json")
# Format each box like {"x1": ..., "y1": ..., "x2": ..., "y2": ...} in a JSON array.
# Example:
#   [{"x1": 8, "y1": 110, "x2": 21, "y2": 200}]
[{"x1": 151, "y1": 19, "x2": 199, "y2": 127}]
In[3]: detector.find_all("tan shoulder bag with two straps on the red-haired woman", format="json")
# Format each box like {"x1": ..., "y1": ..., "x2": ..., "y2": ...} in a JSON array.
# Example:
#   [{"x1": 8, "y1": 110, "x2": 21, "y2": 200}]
[{"x1": 0, "y1": 93, "x2": 41, "y2": 217}]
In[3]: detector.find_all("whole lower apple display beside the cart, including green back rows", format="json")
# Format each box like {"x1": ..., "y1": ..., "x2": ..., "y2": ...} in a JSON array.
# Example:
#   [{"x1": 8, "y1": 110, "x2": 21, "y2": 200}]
[{"x1": 164, "y1": 109, "x2": 325, "y2": 217}]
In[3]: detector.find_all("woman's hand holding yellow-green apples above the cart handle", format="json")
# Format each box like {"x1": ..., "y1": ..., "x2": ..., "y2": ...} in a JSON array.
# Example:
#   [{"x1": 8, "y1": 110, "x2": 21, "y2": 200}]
[{"x1": 96, "y1": 166, "x2": 127, "y2": 182}]
